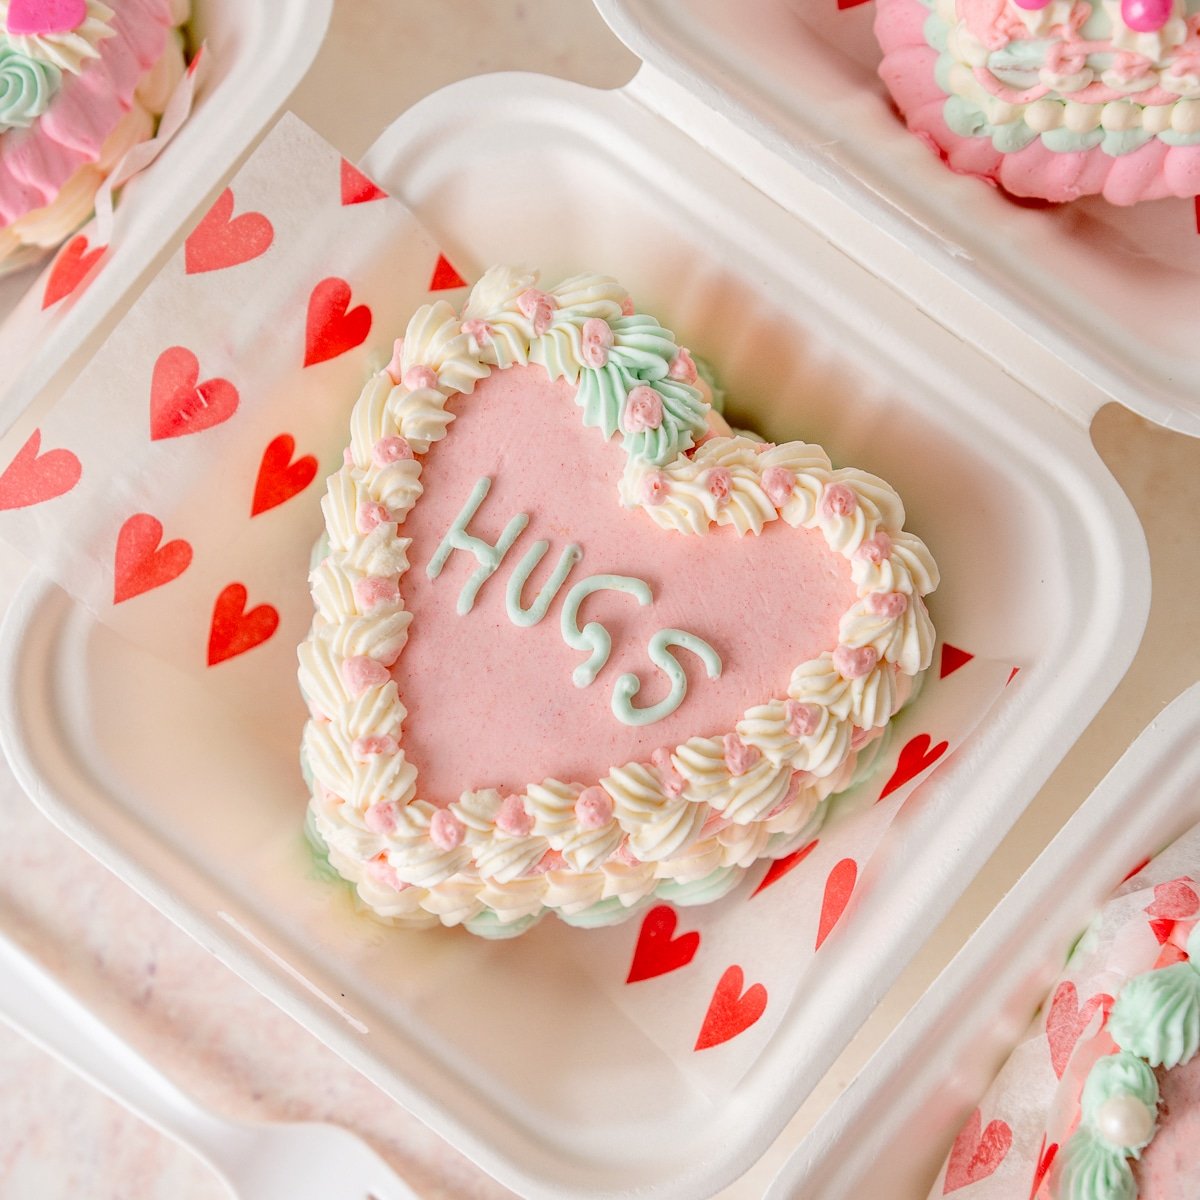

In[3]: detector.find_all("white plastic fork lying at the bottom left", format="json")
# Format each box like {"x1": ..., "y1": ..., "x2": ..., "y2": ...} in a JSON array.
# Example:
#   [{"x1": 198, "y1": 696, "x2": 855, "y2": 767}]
[{"x1": 0, "y1": 932, "x2": 416, "y2": 1200}]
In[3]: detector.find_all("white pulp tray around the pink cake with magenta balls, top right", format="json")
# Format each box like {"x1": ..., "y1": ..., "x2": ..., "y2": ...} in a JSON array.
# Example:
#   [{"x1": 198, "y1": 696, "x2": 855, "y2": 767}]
[{"x1": 596, "y1": 0, "x2": 1200, "y2": 437}]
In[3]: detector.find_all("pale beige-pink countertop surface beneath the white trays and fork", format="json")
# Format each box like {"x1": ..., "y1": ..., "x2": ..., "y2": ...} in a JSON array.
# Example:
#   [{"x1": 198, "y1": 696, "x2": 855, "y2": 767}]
[{"x1": 0, "y1": 0, "x2": 1200, "y2": 1200}]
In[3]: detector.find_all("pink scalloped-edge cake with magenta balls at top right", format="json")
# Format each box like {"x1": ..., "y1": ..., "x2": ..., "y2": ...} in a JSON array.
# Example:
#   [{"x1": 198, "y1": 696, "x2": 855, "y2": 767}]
[{"x1": 875, "y1": 0, "x2": 1200, "y2": 204}]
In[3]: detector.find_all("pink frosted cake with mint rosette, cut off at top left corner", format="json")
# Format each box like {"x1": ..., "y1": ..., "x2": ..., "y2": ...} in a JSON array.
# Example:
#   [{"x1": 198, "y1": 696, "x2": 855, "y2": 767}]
[{"x1": 0, "y1": 0, "x2": 188, "y2": 272}]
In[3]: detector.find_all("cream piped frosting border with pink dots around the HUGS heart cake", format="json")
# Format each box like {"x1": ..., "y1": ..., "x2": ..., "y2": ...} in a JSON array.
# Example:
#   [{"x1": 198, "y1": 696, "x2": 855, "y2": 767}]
[{"x1": 299, "y1": 268, "x2": 938, "y2": 936}]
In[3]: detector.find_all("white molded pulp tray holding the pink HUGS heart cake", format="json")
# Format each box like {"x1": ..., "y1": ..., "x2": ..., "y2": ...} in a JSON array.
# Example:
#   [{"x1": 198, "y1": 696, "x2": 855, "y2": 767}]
[{"x1": 0, "y1": 68, "x2": 1148, "y2": 1200}]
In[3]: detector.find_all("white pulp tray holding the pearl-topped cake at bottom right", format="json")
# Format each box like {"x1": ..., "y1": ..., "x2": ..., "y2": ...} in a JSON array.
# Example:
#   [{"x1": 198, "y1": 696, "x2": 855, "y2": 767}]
[{"x1": 768, "y1": 684, "x2": 1200, "y2": 1200}]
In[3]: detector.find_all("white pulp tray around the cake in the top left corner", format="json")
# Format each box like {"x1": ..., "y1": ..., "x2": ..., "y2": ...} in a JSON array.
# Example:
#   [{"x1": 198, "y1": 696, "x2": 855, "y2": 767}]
[{"x1": 0, "y1": 0, "x2": 334, "y2": 434}]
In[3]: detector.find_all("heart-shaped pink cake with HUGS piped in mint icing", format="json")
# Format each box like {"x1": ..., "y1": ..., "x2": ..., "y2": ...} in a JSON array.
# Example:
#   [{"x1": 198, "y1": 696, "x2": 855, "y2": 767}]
[{"x1": 300, "y1": 268, "x2": 937, "y2": 936}]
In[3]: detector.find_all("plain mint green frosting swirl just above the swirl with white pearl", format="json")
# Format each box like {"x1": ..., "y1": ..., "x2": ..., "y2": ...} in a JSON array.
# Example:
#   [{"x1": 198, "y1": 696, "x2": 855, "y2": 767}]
[{"x1": 1109, "y1": 962, "x2": 1200, "y2": 1069}]
